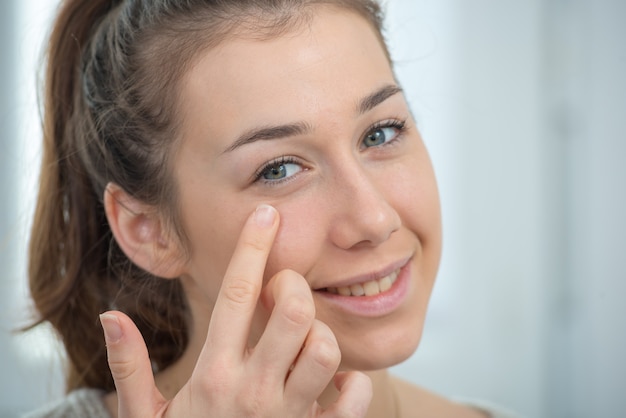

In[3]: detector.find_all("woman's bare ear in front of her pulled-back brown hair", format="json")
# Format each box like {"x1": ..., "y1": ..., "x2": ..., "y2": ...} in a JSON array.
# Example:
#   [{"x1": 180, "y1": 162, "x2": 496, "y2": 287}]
[{"x1": 104, "y1": 183, "x2": 185, "y2": 278}]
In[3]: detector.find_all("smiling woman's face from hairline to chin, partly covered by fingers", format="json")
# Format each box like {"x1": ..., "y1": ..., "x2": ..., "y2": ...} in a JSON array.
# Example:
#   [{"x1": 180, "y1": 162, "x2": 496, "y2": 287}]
[{"x1": 174, "y1": 8, "x2": 441, "y2": 370}]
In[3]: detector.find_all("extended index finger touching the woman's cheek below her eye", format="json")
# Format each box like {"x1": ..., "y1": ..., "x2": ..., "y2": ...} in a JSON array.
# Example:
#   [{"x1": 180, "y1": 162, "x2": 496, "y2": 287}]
[{"x1": 207, "y1": 205, "x2": 278, "y2": 355}]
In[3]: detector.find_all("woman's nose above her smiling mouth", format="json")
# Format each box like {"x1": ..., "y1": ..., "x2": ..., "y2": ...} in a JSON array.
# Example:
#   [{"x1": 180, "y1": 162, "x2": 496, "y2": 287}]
[{"x1": 328, "y1": 165, "x2": 401, "y2": 249}]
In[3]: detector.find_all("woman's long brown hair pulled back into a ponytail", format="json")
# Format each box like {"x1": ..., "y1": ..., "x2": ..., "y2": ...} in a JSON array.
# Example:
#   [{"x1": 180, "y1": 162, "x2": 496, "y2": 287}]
[{"x1": 29, "y1": 0, "x2": 386, "y2": 391}]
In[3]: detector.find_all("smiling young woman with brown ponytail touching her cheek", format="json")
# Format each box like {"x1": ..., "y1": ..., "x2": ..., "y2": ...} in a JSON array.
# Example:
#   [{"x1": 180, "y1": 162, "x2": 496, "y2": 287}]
[{"x1": 30, "y1": 0, "x2": 516, "y2": 418}]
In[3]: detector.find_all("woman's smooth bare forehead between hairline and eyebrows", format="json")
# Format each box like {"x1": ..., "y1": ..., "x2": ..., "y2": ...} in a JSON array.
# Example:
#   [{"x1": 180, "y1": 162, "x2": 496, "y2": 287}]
[{"x1": 176, "y1": 10, "x2": 395, "y2": 150}]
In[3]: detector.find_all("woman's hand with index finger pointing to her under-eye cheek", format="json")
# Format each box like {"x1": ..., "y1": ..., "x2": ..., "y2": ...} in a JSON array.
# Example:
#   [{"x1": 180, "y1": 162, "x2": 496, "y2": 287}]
[{"x1": 101, "y1": 205, "x2": 372, "y2": 418}]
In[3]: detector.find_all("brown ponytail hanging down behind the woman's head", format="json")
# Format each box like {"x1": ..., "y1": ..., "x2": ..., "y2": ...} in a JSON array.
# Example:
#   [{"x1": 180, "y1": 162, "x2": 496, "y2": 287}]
[{"x1": 29, "y1": 0, "x2": 133, "y2": 390}]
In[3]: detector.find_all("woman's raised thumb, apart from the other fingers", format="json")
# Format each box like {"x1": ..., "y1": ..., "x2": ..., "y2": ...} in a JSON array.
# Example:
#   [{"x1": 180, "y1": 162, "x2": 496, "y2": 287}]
[{"x1": 100, "y1": 311, "x2": 165, "y2": 418}]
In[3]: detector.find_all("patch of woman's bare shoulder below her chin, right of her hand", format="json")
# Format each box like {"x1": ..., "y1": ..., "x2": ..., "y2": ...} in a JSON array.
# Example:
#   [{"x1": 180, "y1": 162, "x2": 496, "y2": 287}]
[{"x1": 391, "y1": 376, "x2": 489, "y2": 418}]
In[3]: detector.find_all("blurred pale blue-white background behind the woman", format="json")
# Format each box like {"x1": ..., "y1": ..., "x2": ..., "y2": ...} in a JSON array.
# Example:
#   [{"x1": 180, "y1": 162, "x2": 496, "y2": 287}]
[{"x1": 0, "y1": 0, "x2": 626, "y2": 418}]
